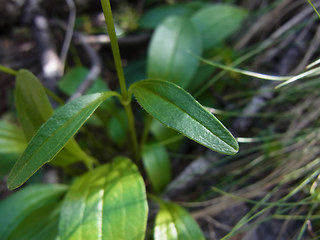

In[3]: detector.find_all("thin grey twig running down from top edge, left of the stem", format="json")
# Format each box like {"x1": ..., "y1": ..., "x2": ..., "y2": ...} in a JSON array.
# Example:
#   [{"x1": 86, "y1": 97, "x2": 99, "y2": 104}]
[{"x1": 60, "y1": 0, "x2": 76, "y2": 75}]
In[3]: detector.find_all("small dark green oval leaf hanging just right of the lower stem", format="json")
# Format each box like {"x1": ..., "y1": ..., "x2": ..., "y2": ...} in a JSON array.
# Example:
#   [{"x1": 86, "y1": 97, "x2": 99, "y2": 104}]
[{"x1": 142, "y1": 145, "x2": 171, "y2": 193}]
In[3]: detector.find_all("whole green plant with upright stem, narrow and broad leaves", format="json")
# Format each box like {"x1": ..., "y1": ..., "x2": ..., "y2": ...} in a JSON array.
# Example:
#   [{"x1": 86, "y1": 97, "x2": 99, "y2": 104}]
[{"x1": 0, "y1": 0, "x2": 245, "y2": 239}]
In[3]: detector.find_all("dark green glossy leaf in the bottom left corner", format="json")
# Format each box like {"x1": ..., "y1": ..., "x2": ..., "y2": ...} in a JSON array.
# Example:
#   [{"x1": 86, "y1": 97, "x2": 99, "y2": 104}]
[{"x1": 0, "y1": 184, "x2": 67, "y2": 239}]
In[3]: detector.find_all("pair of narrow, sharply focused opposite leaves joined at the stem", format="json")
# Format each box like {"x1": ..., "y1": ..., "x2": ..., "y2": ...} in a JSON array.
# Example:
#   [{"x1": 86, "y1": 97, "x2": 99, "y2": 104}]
[{"x1": 8, "y1": 70, "x2": 239, "y2": 189}]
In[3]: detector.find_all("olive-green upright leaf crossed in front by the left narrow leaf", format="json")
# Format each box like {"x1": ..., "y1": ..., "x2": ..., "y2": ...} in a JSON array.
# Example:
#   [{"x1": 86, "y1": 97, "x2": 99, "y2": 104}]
[{"x1": 15, "y1": 70, "x2": 94, "y2": 167}]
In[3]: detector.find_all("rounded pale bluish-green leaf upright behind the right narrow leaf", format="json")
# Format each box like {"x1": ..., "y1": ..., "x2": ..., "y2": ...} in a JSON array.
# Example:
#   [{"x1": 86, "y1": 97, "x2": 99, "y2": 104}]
[{"x1": 147, "y1": 17, "x2": 202, "y2": 88}]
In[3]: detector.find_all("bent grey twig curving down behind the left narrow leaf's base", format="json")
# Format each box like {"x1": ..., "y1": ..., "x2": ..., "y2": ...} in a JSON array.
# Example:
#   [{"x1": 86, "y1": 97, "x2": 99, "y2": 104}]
[{"x1": 68, "y1": 33, "x2": 101, "y2": 101}]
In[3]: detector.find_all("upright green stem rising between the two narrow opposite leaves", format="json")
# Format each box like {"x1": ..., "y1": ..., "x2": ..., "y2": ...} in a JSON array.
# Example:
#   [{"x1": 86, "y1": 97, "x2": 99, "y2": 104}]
[{"x1": 101, "y1": 0, "x2": 140, "y2": 162}]
